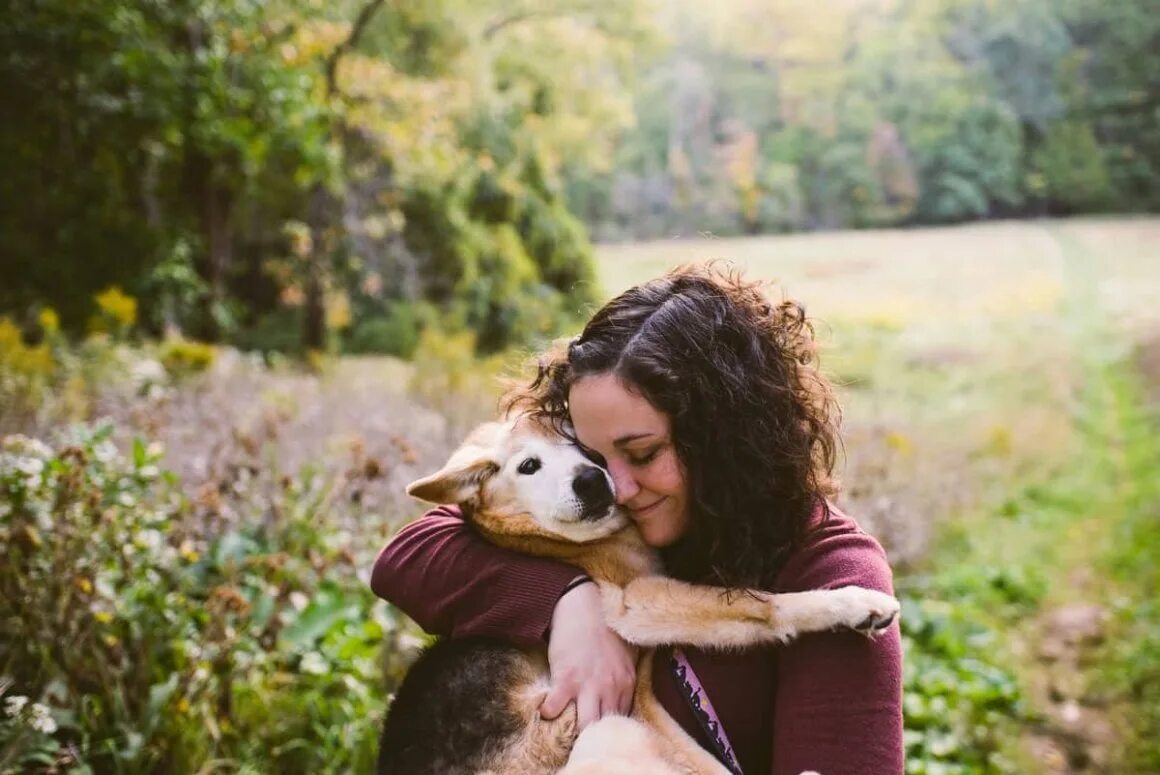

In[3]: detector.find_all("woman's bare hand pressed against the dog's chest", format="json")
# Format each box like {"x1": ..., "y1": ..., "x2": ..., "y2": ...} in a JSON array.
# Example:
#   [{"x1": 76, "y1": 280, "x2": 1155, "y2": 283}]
[{"x1": 539, "y1": 584, "x2": 637, "y2": 730}]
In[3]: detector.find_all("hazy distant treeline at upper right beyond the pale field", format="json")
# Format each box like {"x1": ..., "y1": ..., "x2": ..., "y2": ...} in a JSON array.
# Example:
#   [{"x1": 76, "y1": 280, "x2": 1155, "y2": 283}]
[{"x1": 567, "y1": 0, "x2": 1160, "y2": 239}]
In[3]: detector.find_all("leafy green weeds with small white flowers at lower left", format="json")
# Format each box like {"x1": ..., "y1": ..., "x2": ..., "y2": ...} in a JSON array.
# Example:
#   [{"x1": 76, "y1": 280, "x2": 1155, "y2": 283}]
[{"x1": 0, "y1": 426, "x2": 396, "y2": 772}]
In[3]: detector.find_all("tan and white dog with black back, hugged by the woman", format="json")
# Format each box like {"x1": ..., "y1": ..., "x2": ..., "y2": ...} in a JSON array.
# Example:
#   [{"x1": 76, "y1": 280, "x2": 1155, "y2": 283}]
[{"x1": 378, "y1": 415, "x2": 899, "y2": 775}]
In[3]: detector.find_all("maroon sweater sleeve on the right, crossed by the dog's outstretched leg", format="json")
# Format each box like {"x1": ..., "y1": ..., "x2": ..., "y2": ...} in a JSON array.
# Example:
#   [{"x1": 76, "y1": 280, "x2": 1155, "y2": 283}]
[{"x1": 773, "y1": 517, "x2": 904, "y2": 775}]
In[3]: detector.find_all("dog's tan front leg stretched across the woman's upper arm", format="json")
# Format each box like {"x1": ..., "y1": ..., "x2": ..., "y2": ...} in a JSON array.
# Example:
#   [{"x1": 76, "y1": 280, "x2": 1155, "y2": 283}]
[{"x1": 601, "y1": 575, "x2": 899, "y2": 649}]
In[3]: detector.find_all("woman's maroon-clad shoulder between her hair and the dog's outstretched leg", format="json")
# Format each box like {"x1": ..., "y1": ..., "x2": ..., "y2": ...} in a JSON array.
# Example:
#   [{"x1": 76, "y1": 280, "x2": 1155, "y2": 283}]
[{"x1": 777, "y1": 505, "x2": 893, "y2": 594}]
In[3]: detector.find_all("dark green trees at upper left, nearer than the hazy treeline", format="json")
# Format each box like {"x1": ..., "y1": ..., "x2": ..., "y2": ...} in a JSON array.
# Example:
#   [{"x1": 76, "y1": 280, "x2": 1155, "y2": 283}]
[{"x1": 0, "y1": 0, "x2": 621, "y2": 350}]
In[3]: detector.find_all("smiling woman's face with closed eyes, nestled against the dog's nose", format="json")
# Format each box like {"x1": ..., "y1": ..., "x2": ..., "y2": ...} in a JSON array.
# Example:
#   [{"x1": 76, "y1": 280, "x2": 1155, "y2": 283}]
[{"x1": 568, "y1": 375, "x2": 689, "y2": 546}]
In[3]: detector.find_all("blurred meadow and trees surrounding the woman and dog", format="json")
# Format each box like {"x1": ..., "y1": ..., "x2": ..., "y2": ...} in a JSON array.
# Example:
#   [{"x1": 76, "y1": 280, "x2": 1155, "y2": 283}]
[{"x1": 0, "y1": 0, "x2": 1160, "y2": 773}]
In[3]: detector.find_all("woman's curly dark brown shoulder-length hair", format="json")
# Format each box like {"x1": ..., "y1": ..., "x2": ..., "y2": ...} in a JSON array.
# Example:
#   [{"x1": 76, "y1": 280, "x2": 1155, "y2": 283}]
[{"x1": 506, "y1": 263, "x2": 841, "y2": 589}]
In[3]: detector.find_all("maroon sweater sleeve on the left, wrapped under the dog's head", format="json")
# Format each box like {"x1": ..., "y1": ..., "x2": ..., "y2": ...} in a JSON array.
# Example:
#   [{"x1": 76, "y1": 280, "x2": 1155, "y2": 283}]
[{"x1": 370, "y1": 506, "x2": 581, "y2": 645}]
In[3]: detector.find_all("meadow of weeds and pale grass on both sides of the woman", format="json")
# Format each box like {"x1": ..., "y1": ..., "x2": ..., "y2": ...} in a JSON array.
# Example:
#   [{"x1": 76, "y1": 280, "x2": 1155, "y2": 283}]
[{"x1": 0, "y1": 218, "x2": 1160, "y2": 773}]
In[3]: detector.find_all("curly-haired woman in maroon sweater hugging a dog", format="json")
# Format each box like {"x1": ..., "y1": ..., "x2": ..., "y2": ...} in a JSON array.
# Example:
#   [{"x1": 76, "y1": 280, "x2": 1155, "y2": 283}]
[{"x1": 371, "y1": 267, "x2": 902, "y2": 775}]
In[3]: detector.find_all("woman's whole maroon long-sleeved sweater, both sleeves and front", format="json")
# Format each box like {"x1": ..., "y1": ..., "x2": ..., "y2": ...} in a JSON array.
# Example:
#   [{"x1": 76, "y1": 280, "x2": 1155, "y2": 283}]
[{"x1": 370, "y1": 506, "x2": 902, "y2": 775}]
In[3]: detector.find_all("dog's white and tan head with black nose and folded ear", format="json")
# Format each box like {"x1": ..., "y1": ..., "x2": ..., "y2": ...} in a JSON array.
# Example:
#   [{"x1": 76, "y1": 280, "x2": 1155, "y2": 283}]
[{"x1": 407, "y1": 418, "x2": 629, "y2": 543}]
